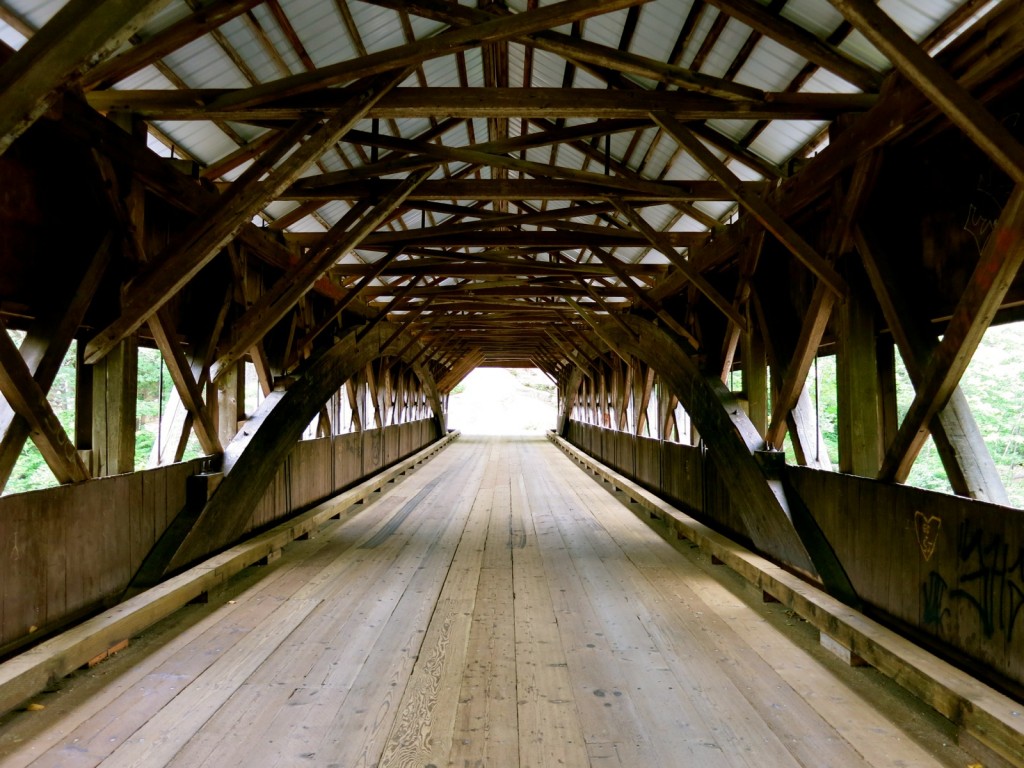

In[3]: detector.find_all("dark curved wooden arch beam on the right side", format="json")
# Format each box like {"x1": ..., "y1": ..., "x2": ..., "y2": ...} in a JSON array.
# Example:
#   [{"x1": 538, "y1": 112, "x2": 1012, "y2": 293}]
[{"x1": 591, "y1": 315, "x2": 858, "y2": 604}]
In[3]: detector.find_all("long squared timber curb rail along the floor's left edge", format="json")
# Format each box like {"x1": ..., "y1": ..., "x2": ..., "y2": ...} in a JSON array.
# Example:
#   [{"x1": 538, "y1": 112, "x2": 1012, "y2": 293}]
[{"x1": 0, "y1": 431, "x2": 460, "y2": 714}]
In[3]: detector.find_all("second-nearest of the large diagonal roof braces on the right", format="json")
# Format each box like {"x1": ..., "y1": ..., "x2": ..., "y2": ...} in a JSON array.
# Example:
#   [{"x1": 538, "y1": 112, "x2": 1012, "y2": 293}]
[{"x1": 652, "y1": 113, "x2": 846, "y2": 298}]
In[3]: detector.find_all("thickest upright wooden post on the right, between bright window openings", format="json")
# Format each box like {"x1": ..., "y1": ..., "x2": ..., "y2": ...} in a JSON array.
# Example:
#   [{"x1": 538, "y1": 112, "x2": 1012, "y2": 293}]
[{"x1": 836, "y1": 263, "x2": 882, "y2": 477}]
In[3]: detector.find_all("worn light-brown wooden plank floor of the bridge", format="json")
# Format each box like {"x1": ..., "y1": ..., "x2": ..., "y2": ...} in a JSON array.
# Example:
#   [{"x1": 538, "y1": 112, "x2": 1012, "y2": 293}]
[{"x1": 0, "y1": 437, "x2": 977, "y2": 768}]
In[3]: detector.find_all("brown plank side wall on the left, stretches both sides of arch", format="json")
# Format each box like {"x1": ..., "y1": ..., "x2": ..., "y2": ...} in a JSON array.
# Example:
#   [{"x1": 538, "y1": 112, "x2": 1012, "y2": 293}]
[{"x1": 0, "y1": 420, "x2": 448, "y2": 651}]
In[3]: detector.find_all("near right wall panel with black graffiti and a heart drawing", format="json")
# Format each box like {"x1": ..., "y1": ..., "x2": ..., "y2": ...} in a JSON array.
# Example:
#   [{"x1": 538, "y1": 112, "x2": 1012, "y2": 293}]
[{"x1": 787, "y1": 467, "x2": 1024, "y2": 695}]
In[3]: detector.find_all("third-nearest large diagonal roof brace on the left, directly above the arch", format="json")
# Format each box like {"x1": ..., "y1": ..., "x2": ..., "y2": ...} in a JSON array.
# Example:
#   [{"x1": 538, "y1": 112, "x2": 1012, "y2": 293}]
[{"x1": 213, "y1": 169, "x2": 433, "y2": 380}]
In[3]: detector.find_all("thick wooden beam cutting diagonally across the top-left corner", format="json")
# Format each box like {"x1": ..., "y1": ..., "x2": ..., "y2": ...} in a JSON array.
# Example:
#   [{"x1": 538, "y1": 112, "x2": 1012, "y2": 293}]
[{"x1": 0, "y1": 0, "x2": 168, "y2": 154}]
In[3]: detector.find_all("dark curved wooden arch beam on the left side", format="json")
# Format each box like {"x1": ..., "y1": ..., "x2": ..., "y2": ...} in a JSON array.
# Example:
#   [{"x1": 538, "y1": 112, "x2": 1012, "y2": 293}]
[{"x1": 164, "y1": 323, "x2": 446, "y2": 573}]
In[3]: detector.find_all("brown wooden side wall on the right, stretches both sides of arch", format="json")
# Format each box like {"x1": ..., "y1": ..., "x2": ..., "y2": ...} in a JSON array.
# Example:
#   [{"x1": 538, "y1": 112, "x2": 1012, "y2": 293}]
[{"x1": 567, "y1": 422, "x2": 1024, "y2": 698}]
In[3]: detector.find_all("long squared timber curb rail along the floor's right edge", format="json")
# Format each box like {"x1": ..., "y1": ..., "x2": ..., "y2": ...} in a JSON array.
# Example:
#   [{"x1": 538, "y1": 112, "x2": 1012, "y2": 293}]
[{"x1": 548, "y1": 433, "x2": 1024, "y2": 766}]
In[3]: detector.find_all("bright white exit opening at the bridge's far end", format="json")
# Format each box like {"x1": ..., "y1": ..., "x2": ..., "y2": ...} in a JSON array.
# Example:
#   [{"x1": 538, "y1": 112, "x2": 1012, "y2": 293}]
[{"x1": 449, "y1": 368, "x2": 557, "y2": 435}]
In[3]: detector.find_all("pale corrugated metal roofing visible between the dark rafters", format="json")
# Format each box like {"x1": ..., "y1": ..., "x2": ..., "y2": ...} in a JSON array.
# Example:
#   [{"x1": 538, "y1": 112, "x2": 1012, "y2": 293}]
[{"x1": 0, "y1": 0, "x2": 983, "y2": 274}]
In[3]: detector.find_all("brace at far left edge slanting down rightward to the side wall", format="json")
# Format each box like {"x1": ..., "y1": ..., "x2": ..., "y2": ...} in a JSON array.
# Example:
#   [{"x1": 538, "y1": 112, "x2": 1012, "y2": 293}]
[{"x1": 0, "y1": 321, "x2": 89, "y2": 482}]
